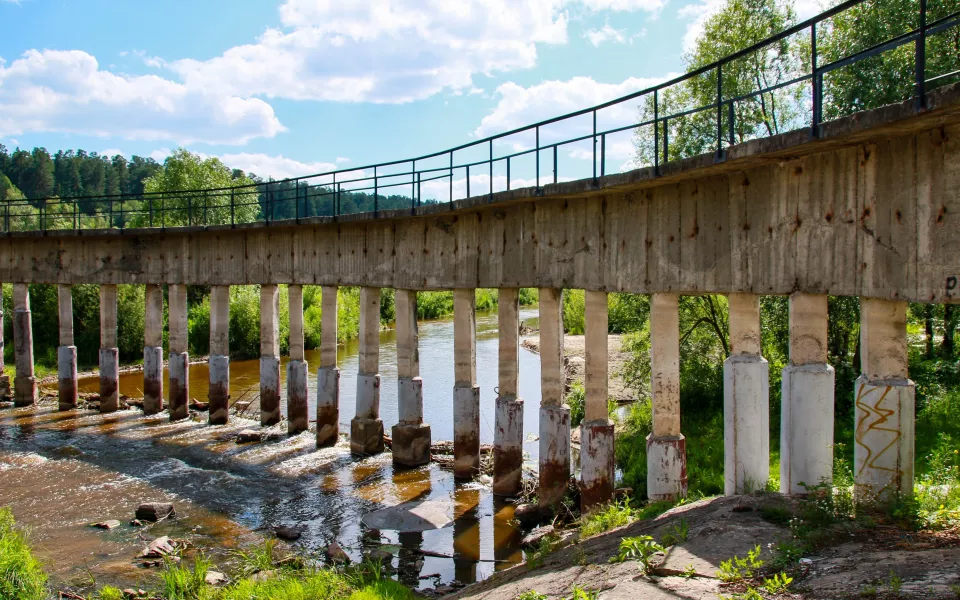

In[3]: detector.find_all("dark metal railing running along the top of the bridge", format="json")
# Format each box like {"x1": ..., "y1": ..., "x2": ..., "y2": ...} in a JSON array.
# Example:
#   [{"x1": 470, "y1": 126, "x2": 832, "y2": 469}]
[{"x1": 0, "y1": 0, "x2": 960, "y2": 233}]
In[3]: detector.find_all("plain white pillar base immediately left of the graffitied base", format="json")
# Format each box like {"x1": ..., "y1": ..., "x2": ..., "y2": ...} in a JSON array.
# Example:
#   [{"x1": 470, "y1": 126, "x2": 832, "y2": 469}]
[{"x1": 780, "y1": 363, "x2": 835, "y2": 494}]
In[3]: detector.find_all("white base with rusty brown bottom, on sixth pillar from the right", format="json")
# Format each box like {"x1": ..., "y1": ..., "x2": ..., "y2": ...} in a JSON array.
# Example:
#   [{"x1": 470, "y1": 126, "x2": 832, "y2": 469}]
[{"x1": 538, "y1": 404, "x2": 570, "y2": 510}]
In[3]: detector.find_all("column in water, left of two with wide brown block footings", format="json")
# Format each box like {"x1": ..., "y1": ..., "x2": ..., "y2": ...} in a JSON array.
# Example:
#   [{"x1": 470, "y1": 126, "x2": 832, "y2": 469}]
[{"x1": 350, "y1": 287, "x2": 383, "y2": 454}]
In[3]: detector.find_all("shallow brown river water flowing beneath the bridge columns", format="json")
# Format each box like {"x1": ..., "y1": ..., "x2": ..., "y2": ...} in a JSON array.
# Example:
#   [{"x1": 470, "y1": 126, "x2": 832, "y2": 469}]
[{"x1": 0, "y1": 309, "x2": 540, "y2": 589}]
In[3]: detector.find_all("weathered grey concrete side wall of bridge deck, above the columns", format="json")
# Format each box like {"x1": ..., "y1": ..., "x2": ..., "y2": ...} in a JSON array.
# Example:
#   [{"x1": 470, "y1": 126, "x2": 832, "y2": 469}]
[{"x1": 7, "y1": 85, "x2": 960, "y2": 302}]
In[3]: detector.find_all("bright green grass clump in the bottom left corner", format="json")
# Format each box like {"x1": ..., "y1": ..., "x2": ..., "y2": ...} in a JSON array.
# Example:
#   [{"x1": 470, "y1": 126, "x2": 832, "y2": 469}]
[{"x1": 0, "y1": 508, "x2": 47, "y2": 600}]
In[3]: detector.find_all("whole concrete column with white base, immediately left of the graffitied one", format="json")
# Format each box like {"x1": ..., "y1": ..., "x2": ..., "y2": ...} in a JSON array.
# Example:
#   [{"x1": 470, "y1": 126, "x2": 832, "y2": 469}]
[{"x1": 780, "y1": 292, "x2": 835, "y2": 494}]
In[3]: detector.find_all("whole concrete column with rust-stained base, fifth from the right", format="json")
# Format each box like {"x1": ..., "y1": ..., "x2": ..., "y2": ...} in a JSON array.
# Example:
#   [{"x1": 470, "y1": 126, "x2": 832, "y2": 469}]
[{"x1": 580, "y1": 291, "x2": 616, "y2": 513}]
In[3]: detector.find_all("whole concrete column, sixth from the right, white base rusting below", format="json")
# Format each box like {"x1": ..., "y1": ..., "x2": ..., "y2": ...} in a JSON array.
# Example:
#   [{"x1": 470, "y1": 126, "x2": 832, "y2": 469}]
[{"x1": 539, "y1": 288, "x2": 570, "y2": 510}]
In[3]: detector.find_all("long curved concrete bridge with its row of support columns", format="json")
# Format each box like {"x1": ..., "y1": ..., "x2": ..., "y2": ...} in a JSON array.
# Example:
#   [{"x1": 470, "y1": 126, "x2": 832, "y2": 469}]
[{"x1": 0, "y1": 85, "x2": 960, "y2": 508}]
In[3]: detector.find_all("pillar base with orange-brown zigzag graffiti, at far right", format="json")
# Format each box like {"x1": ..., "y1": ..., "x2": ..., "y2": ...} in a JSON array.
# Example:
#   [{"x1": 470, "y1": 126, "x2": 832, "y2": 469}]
[{"x1": 853, "y1": 375, "x2": 916, "y2": 504}]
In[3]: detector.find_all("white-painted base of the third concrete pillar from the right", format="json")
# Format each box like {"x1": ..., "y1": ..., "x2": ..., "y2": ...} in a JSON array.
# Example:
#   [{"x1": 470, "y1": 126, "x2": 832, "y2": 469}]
[{"x1": 723, "y1": 354, "x2": 770, "y2": 496}]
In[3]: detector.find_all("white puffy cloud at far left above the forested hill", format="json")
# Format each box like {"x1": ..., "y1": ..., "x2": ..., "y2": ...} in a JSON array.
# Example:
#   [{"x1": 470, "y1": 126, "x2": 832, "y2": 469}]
[{"x1": 0, "y1": 50, "x2": 284, "y2": 144}]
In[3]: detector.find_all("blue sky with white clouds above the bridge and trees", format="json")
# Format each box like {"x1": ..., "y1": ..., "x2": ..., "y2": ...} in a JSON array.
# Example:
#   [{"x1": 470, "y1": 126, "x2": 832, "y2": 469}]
[{"x1": 0, "y1": 0, "x2": 818, "y2": 185}]
